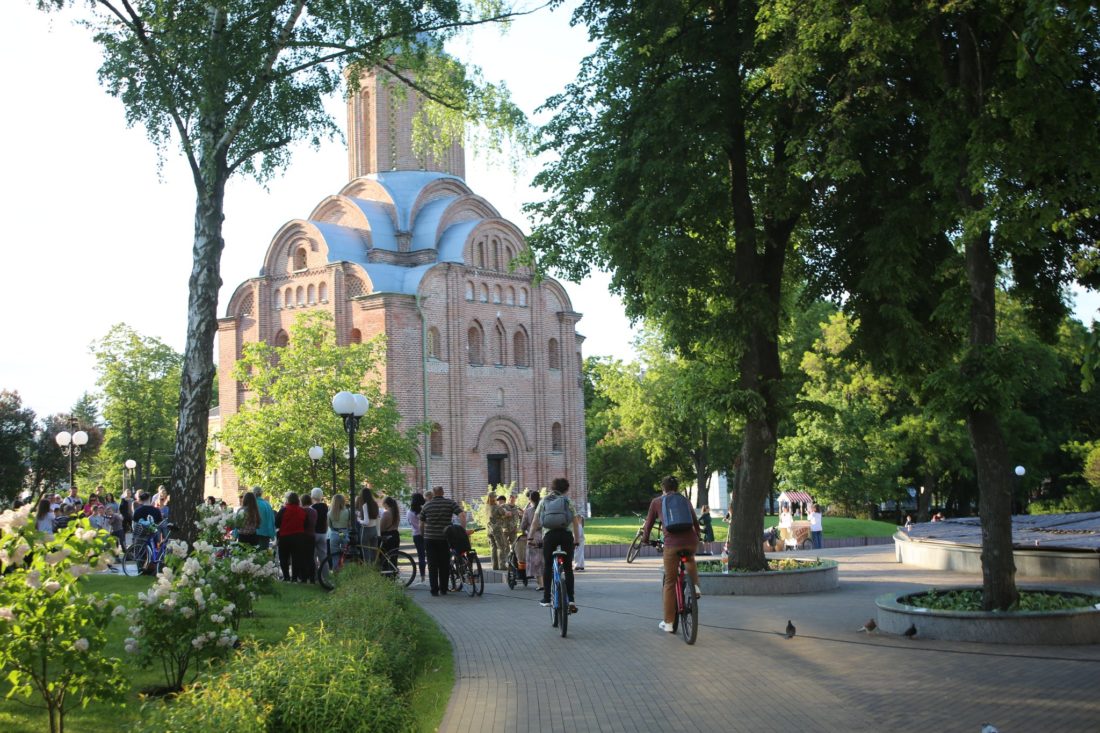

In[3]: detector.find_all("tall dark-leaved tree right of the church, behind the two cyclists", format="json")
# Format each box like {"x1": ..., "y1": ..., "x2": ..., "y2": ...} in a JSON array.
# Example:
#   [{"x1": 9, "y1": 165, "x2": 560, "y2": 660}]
[{"x1": 529, "y1": 0, "x2": 811, "y2": 569}]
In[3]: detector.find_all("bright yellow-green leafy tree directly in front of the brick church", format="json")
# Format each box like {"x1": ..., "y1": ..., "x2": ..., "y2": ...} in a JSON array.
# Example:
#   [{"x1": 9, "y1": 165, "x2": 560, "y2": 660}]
[{"x1": 219, "y1": 311, "x2": 420, "y2": 496}]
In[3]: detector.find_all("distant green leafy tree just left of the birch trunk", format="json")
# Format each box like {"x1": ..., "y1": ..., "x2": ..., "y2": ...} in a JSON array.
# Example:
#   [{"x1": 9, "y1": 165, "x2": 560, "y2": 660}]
[{"x1": 91, "y1": 324, "x2": 183, "y2": 489}]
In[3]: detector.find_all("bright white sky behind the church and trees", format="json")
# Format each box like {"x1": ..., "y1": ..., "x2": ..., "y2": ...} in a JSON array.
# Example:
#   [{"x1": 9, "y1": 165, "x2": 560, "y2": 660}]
[{"x1": 0, "y1": 0, "x2": 634, "y2": 416}]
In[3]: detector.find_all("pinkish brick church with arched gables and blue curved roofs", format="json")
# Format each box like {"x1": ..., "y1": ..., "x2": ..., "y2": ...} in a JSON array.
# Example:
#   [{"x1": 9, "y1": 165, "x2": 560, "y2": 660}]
[{"x1": 207, "y1": 68, "x2": 587, "y2": 506}]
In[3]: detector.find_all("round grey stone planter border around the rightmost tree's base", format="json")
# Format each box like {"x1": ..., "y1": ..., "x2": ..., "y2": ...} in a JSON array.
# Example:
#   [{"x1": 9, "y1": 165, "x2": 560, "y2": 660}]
[{"x1": 875, "y1": 586, "x2": 1100, "y2": 645}]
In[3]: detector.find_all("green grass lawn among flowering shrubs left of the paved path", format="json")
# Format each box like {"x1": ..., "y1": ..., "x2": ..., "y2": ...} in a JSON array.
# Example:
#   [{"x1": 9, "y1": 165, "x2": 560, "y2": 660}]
[{"x1": 0, "y1": 575, "x2": 454, "y2": 733}]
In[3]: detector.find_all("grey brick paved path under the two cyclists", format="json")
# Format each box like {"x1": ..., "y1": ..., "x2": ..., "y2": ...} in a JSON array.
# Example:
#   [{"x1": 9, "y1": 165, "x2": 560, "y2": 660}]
[{"x1": 414, "y1": 547, "x2": 1100, "y2": 733}]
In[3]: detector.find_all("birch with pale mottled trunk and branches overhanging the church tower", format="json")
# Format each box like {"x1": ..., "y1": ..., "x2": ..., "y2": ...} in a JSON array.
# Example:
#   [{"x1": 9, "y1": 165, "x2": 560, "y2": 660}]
[{"x1": 35, "y1": 0, "x2": 521, "y2": 534}]
